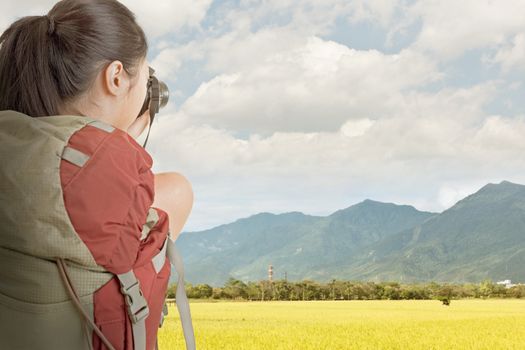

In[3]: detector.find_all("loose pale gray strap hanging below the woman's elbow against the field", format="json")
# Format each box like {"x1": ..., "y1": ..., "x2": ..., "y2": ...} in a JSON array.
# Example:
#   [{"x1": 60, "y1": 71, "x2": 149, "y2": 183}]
[{"x1": 166, "y1": 234, "x2": 195, "y2": 350}]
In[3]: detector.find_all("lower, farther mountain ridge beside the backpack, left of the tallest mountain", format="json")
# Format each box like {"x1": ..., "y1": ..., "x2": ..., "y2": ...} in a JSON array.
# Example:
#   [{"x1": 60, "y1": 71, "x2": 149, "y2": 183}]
[{"x1": 177, "y1": 200, "x2": 435, "y2": 285}]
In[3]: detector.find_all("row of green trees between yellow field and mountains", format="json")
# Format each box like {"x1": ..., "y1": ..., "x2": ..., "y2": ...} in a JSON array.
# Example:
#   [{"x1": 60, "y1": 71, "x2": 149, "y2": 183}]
[{"x1": 167, "y1": 278, "x2": 525, "y2": 301}]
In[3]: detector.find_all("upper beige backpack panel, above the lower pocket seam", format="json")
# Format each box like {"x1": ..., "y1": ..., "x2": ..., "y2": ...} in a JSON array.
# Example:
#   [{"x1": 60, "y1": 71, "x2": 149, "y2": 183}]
[{"x1": 0, "y1": 111, "x2": 104, "y2": 271}]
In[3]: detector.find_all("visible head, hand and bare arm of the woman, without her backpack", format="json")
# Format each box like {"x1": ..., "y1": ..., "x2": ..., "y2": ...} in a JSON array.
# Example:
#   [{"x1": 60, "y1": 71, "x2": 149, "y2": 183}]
[{"x1": 0, "y1": 0, "x2": 193, "y2": 239}]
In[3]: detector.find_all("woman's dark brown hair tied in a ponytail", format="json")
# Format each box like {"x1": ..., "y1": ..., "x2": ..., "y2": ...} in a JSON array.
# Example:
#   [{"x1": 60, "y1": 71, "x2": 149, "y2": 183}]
[{"x1": 0, "y1": 0, "x2": 148, "y2": 117}]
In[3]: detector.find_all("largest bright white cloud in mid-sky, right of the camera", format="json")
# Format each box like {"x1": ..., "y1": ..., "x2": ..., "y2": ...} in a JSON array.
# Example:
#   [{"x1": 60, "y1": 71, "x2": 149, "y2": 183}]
[{"x1": 181, "y1": 33, "x2": 440, "y2": 134}]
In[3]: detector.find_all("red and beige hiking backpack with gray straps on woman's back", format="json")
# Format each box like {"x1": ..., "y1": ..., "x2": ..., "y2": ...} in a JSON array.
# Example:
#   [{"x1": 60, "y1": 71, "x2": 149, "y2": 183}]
[{"x1": 0, "y1": 111, "x2": 195, "y2": 350}]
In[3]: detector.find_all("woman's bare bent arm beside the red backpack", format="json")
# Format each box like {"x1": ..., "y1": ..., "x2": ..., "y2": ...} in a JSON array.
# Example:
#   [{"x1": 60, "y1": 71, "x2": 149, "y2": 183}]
[{"x1": 152, "y1": 172, "x2": 193, "y2": 240}]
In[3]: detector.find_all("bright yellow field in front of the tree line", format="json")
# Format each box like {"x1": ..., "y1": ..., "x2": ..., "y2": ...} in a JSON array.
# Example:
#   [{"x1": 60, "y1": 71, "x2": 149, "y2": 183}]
[{"x1": 159, "y1": 299, "x2": 525, "y2": 350}]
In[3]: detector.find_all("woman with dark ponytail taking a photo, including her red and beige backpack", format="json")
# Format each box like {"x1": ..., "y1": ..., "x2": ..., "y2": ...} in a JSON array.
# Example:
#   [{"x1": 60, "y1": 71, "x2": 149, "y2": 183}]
[{"x1": 0, "y1": 0, "x2": 193, "y2": 349}]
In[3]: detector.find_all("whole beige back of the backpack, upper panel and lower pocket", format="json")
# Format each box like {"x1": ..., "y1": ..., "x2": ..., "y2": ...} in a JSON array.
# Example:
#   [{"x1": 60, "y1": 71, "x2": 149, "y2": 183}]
[{"x1": 0, "y1": 111, "x2": 113, "y2": 350}]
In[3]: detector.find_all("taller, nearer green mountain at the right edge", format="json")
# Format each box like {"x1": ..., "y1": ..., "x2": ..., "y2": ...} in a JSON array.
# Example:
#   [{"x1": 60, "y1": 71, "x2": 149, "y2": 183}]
[{"x1": 346, "y1": 181, "x2": 525, "y2": 282}]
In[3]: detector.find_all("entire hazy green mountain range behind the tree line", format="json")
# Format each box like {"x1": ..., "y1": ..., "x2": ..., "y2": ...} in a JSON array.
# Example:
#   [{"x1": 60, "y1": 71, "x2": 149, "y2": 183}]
[{"x1": 172, "y1": 181, "x2": 525, "y2": 285}]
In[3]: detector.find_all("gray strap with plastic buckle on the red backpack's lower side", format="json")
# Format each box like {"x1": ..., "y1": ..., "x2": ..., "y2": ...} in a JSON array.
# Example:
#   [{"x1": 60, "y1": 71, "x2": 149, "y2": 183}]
[{"x1": 117, "y1": 270, "x2": 149, "y2": 350}]
